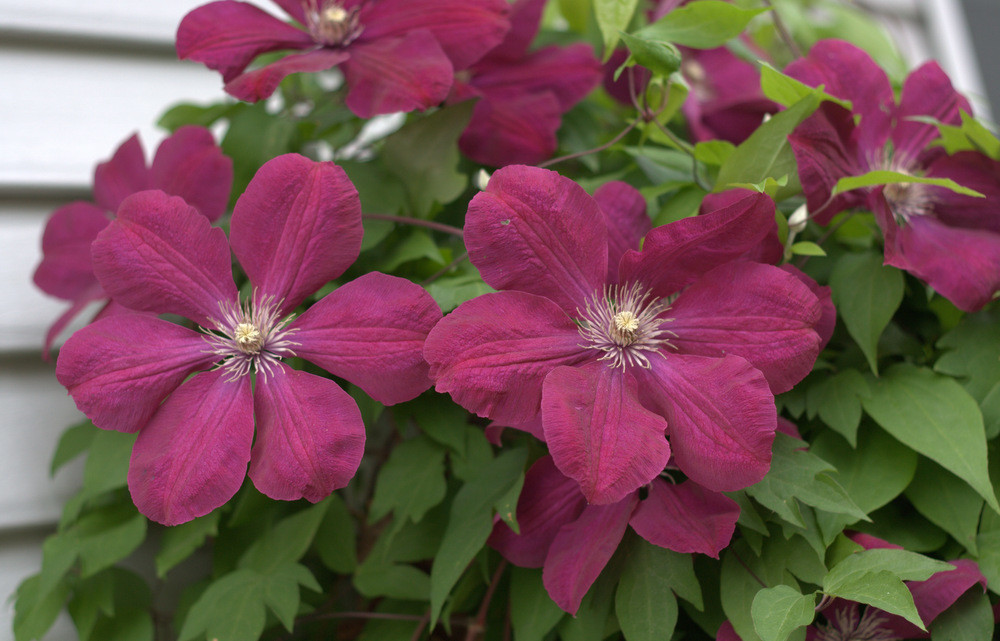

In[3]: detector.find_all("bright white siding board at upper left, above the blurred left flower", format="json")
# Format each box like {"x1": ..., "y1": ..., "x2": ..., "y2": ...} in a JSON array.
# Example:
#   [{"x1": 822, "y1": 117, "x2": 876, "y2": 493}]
[{"x1": 0, "y1": 45, "x2": 225, "y2": 190}]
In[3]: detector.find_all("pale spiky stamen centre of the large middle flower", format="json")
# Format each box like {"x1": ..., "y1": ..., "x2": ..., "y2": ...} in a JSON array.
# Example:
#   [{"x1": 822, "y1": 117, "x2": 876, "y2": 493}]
[{"x1": 577, "y1": 283, "x2": 676, "y2": 369}]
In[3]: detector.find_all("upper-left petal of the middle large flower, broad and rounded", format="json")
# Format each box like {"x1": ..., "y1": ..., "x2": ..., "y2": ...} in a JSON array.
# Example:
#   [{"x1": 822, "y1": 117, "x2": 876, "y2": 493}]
[{"x1": 465, "y1": 166, "x2": 608, "y2": 314}]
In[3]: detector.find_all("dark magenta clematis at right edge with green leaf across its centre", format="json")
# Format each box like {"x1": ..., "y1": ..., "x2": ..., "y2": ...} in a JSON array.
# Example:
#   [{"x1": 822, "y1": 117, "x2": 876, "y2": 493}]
[{"x1": 786, "y1": 40, "x2": 1000, "y2": 311}]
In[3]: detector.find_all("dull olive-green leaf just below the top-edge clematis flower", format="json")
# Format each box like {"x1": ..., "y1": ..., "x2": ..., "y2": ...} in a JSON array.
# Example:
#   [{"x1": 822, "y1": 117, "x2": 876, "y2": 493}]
[{"x1": 382, "y1": 100, "x2": 475, "y2": 217}]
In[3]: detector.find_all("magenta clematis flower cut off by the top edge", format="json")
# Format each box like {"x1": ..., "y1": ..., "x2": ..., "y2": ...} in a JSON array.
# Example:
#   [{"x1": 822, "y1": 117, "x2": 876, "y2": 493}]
[{"x1": 177, "y1": 0, "x2": 509, "y2": 118}]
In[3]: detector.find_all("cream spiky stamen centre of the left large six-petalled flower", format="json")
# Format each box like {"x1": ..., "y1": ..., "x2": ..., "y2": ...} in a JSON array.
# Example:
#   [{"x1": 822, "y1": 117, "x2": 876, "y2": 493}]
[{"x1": 202, "y1": 297, "x2": 298, "y2": 381}]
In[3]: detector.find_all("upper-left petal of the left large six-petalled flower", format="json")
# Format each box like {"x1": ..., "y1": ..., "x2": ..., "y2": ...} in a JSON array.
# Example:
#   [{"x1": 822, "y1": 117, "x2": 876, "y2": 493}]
[{"x1": 91, "y1": 191, "x2": 237, "y2": 327}]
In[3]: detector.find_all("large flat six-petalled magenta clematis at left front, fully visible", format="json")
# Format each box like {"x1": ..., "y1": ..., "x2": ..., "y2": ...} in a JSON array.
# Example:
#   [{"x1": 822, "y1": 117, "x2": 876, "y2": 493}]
[{"x1": 56, "y1": 154, "x2": 441, "y2": 525}]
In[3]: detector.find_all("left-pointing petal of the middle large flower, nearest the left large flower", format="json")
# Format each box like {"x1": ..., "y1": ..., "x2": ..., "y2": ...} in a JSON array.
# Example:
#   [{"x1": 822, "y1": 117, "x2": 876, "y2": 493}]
[{"x1": 424, "y1": 292, "x2": 595, "y2": 424}]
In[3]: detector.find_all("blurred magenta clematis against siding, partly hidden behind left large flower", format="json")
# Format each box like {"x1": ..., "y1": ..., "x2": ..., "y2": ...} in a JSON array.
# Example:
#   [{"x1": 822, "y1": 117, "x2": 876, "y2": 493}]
[{"x1": 34, "y1": 126, "x2": 233, "y2": 358}]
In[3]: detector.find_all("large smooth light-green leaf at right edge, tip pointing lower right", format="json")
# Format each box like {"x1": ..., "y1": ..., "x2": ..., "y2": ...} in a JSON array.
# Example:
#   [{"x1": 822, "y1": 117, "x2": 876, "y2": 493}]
[{"x1": 862, "y1": 364, "x2": 1000, "y2": 512}]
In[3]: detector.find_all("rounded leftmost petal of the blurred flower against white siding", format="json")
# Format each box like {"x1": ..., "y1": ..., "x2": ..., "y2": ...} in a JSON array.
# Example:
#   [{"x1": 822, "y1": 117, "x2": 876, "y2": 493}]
[{"x1": 34, "y1": 202, "x2": 111, "y2": 300}]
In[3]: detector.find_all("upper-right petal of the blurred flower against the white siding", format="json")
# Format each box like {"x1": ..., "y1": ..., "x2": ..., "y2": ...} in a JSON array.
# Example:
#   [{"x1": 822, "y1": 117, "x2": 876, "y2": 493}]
[{"x1": 150, "y1": 125, "x2": 233, "y2": 220}]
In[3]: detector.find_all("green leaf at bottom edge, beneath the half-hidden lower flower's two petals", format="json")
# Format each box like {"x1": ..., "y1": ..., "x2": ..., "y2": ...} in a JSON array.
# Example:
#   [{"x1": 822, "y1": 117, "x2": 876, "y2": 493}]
[{"x1": 615, "y1": 541, "x2": 677, "y2": 641}]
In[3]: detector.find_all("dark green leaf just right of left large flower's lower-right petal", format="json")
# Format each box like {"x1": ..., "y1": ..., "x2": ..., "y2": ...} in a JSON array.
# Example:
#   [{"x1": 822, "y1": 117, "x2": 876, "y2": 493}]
[{"x1": 369, "y1": 436, "x2": 448, "y2": 522}]
